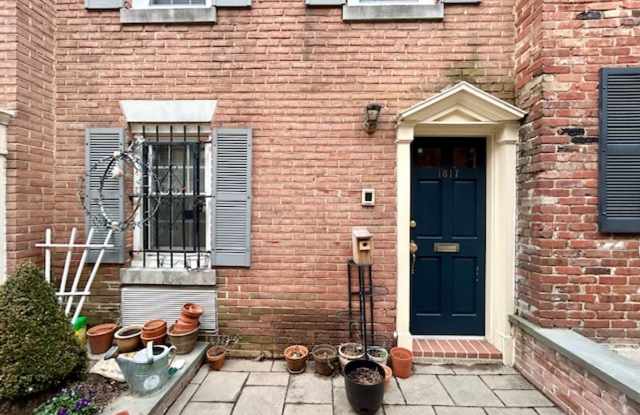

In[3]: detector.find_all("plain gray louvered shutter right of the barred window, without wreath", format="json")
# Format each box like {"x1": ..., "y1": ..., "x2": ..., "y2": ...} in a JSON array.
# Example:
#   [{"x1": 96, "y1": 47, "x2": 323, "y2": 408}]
[{"x1": 211, "y1": 128, "x2": 251, "y2": 267}]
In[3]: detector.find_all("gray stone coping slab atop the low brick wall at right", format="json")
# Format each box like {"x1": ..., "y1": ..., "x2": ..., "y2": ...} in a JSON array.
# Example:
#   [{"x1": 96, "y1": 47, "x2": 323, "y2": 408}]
[{"x1": 509, "y1": 315, "x2": 640, "y2": 402}]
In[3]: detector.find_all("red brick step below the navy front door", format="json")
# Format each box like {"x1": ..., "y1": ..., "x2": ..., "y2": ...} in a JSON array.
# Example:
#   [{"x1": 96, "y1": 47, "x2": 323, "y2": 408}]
[{"x1": 413, "y1": 338, "x2": 502, "y2": 362}]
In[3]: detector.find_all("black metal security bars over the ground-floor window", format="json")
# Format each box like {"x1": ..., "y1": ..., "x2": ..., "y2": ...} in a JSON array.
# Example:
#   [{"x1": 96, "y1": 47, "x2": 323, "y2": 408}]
[{"x1": 134, "y1": 126, "x2": 211, "y2": 269}]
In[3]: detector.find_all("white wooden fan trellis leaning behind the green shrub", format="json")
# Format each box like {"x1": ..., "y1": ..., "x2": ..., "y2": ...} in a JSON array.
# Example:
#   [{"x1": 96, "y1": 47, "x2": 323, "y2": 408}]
[{"x1": 36, "y1": 227, "x2": 113, "y2": 324}]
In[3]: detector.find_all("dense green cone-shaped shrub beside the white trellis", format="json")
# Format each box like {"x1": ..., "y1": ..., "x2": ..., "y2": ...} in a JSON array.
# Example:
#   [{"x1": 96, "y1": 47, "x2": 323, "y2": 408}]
[{"x1": 0, "y1": 263, "x2": 87, "y2": 399}]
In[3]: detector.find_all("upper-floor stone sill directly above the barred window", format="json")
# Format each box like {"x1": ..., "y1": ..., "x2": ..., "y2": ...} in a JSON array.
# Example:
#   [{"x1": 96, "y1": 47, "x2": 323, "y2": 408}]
[{"x1": 120, "y1": 7, "x2": 216, "y2": 24}]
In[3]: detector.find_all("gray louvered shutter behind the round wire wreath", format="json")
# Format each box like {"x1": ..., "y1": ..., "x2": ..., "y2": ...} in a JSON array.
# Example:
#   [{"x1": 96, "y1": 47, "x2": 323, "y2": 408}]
[{"x1": 85, "y1": 128, "x2": 124, "y2": 264}]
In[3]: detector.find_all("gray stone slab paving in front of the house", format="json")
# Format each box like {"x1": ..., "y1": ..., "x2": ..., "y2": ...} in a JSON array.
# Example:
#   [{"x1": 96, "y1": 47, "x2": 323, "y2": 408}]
[{"x1": 167, "y1": 359, "x2": 562, "y2": 415}]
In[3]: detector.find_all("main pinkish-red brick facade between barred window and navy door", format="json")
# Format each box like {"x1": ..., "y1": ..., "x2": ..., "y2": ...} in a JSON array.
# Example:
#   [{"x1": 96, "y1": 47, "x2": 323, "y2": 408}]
[{"x1": 55, "y1": 0, "x2": 514, "y2": 351}]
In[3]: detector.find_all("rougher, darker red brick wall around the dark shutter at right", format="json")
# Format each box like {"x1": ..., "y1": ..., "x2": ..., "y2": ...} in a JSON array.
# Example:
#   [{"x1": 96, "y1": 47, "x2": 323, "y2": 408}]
[{"x1": 516, "y1": 0, "x2": 640, "y2": 342}]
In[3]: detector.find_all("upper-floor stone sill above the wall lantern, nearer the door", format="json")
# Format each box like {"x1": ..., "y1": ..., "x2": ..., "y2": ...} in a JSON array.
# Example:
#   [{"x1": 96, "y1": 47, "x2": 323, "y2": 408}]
[{"x1": 342, "y1": 2, "x2": 444, "y2": 21}]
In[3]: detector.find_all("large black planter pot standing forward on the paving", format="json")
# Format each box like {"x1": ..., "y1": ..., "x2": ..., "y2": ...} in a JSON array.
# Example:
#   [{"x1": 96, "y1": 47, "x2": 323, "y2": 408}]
[{"x1": 344, "y1": 360, "x2": 385, "y2": 415}]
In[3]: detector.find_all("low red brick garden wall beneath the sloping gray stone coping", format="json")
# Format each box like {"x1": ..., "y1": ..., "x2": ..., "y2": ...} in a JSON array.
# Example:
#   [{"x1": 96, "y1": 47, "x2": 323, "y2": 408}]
[{"x1": 515, "y1": 329, "x2": 640, "y2": 415}]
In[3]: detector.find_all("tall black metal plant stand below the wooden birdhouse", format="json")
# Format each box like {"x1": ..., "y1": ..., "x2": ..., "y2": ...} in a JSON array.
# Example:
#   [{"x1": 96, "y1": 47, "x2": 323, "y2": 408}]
[{"x1": 347, "y1": 259, "x2": 375, "y2": 357}]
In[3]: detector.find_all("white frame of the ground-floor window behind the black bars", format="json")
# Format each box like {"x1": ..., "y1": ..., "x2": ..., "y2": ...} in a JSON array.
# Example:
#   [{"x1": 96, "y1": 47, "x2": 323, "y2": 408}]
[{"x1": 132, "y1": 132, "x2": 213, "y2": 270}]
